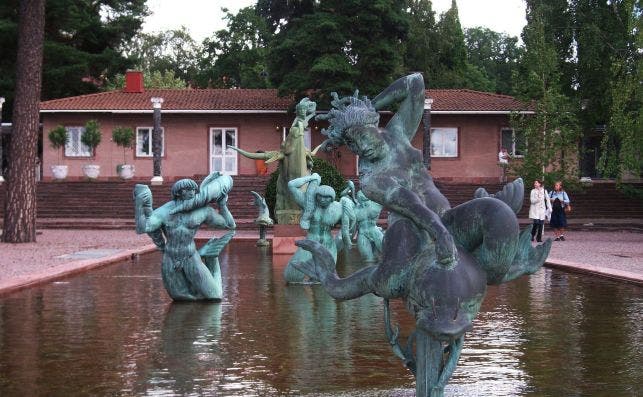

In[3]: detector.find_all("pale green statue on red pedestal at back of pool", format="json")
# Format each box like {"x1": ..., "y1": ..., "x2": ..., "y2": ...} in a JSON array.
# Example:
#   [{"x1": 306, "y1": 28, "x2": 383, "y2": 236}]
[{"x1": 228, "y1": 98, "x2": 317, "y2": 225}]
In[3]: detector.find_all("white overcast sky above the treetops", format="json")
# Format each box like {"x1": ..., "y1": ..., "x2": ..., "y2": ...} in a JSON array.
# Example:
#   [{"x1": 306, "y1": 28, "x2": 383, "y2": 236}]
[{"x1": 143, "y1": 0, "x2": 526, "y2": 42}]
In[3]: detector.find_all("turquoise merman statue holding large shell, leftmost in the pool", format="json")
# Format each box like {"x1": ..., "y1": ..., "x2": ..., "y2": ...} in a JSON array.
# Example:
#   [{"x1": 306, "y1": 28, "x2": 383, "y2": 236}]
[{"x1": 134, "y1": 173, "x2": 236, "y2": 301}]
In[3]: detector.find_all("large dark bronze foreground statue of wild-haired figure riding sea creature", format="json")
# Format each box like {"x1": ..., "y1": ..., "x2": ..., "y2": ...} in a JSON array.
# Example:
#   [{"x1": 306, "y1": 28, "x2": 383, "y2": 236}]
[{"x1": 297, "y1": 74, "x2": 551, "y2": 397}]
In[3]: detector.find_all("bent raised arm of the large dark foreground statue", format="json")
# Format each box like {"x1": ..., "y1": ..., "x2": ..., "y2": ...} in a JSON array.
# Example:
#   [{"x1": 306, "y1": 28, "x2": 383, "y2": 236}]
[{"x1": 372, "y1": 73, "x2": 424, "y2": 141}]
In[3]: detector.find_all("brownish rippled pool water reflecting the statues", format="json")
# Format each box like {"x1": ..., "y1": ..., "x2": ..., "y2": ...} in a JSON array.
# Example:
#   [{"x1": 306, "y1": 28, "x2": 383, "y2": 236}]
[{"x1": 0, "y1": 241, "x2": 643, "y2": 396}]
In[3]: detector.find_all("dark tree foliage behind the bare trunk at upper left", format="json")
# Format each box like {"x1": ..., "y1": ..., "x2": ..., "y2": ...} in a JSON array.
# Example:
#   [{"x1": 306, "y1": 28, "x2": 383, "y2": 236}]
[{"x1": 0, "y1": 0, "x2": 148, "y2": 120}]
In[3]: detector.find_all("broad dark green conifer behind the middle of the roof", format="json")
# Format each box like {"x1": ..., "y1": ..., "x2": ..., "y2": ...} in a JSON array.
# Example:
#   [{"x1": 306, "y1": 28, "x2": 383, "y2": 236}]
[{"x1": 268, "y1": 0, "x2": 408, "y2": 102}]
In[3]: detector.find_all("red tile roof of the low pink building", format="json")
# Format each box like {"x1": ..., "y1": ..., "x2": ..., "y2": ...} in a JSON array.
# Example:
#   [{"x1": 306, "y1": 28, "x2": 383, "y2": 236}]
[{"x1": 40, "y1": 89, "x2": 529, "y2": 113}]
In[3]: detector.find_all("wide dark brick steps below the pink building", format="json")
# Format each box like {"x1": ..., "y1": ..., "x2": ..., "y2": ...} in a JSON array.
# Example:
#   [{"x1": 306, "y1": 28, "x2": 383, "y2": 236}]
[{"x1": 0, "y1": 176, "x2": 643, "y2": 230}]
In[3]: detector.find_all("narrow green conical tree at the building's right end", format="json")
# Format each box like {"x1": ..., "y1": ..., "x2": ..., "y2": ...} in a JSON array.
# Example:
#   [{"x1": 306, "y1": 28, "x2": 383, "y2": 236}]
[{"x1": 512, "y1": 2, "x2": 579, "y2": 183}]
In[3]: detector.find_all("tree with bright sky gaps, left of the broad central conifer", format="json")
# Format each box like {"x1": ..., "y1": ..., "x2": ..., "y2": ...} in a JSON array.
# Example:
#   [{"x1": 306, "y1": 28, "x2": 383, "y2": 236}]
[{"x1": 196, "y1": 7, "x2": 272, "y2": 88}]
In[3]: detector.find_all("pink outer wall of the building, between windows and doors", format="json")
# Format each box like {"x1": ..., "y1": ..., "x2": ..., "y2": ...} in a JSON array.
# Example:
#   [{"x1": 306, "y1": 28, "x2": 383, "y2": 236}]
[{"x1": 43, "y1": 113, "x2": 508, "y2": 183}]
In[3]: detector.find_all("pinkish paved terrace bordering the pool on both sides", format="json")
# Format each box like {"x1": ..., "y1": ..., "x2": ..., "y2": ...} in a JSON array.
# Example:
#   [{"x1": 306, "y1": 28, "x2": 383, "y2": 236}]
[{"x1": 0, "y1": 229, "x2": 643, "y2": 294}]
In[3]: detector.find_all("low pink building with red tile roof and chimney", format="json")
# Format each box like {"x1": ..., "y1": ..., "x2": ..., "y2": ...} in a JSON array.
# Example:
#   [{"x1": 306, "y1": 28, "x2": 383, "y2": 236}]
[{"x1": 41, "y1": 74, "x2": 531, "y2": 183}]
